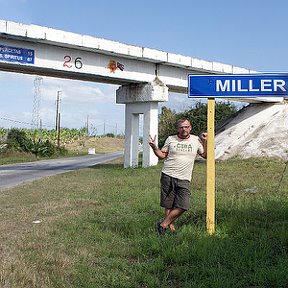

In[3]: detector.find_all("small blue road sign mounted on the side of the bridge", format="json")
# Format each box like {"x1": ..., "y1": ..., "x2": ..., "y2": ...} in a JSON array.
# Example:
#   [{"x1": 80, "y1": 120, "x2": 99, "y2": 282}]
[{"x1": 0, "y1": 45, "x2": 34, "y2": 64}]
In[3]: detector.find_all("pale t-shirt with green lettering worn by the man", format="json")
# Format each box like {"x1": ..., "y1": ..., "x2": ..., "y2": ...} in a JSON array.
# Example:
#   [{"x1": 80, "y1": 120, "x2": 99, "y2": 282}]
[{"x1": 161, "y1": 134, "x2": 204, "y2": 181}]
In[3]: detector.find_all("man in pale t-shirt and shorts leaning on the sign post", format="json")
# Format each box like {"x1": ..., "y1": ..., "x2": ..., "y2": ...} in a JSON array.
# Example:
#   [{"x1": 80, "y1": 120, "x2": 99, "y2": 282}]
[{"x1": 149, "y1": 119, "x2": 207, "y2": 235}]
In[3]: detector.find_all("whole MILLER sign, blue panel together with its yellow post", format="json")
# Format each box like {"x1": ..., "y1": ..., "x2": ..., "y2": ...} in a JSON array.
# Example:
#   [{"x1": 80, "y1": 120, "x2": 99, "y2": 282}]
[{"x1": 188, "y1": 73, "x2": 288, "y2": 235}]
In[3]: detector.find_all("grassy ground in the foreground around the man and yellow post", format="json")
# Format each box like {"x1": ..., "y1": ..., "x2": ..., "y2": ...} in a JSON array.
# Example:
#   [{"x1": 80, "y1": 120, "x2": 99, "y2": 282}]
[{"x1": 0, "y1": 159, "x2": 288, "y2": 288}]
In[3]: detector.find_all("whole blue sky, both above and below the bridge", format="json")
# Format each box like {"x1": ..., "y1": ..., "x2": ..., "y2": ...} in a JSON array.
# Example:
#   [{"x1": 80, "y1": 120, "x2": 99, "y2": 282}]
[{"x1": 0, "y1": 0, "x2": 288, "y2": 134}]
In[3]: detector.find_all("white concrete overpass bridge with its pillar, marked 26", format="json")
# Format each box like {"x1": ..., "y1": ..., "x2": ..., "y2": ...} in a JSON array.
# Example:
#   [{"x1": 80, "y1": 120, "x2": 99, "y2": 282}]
[{"x1": 0, "y1": 20, "x2": 282, "y2": 167}]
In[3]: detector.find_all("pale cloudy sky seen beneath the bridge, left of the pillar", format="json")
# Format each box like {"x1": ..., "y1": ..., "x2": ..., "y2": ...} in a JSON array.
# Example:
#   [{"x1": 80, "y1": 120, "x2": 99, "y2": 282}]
[{"x1": 0, "y1": 72, "x2": 124, "y2": 133}]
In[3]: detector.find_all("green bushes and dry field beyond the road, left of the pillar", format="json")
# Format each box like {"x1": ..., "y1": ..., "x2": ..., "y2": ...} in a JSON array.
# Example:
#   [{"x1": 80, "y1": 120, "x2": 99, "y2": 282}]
[{"x1": 0, "y1": 128, "x2": 124, "y2": 165}]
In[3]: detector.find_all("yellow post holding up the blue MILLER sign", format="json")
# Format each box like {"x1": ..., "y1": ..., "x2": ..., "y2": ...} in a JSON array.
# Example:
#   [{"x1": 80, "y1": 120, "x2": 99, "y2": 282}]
[{"x1": 206, "y1": 98, "x2": 215, "y2": 235}]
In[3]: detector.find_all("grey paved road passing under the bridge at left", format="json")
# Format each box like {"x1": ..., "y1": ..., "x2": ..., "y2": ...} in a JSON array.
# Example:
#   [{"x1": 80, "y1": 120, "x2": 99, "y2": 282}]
[{"x1": 0, "y1": 152, "x2": 123, "y2": 189}]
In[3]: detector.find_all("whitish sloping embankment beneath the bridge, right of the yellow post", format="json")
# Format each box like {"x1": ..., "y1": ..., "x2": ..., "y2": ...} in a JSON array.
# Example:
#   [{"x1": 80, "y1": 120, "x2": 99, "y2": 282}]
[{"x1": 215, "y1": 102, "x2": 288, "y2": 161}]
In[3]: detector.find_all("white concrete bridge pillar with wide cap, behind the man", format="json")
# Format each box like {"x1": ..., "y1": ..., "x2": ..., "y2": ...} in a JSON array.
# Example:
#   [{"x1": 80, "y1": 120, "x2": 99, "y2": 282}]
[{"x1": 116, "y1": 78, "x2": 168, "y2": 168}]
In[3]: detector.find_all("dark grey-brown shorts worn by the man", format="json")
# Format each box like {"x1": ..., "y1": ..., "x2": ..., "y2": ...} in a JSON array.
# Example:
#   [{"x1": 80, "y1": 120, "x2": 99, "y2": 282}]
[{"x1": 160, "y1": 173, "x2": 191, "y2": 210}]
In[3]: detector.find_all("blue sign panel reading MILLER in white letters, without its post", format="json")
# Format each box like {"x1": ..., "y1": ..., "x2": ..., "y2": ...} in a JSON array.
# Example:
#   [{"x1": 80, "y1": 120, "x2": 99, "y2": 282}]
[{"x1": 188, "y1": 73, "x2": 288, "y2": 98}]
